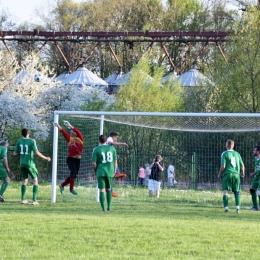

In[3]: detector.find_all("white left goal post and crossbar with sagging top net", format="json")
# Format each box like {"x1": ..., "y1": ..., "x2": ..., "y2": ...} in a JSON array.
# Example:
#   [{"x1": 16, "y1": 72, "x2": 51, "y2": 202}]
[{"x1": 51, "y1": 111, "x2": 260, "y2": 202}]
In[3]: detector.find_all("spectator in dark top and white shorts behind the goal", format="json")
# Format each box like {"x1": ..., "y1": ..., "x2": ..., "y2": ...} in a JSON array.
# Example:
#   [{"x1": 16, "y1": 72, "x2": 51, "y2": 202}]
[{"x1": 148, "y1": 154, "x2": 164, "y2": 198}]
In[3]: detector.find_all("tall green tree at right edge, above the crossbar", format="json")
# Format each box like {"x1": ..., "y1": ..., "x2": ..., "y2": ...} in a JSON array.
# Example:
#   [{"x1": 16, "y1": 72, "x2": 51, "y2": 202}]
[{"x1": 210, "y1": 6, "x2": 260, "y2": 113}]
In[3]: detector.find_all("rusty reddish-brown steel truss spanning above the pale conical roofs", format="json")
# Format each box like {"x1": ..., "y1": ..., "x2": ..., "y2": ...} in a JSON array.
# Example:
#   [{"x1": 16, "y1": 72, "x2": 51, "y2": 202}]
[{"x1": 0, "y1": 30, "x2": 229, "y2": 72}]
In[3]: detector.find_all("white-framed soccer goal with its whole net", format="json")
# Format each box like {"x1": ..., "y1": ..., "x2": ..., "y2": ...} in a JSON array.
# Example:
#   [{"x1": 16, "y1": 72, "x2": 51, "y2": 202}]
[{"x1": 51, "y1": 111, "x2": 260, "y2": 202}]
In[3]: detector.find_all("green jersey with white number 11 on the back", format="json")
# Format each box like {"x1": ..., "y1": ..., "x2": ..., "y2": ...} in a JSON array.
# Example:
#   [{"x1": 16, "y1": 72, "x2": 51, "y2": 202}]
[{"x1": 14, "y1": 138, "x2": 38, "y2": 168}]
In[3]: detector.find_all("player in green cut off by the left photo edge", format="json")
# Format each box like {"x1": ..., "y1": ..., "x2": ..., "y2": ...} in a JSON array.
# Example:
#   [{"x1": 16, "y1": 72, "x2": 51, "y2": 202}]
[{"x1": 0, "y1": 141, "x2": 10, "y2": 202}]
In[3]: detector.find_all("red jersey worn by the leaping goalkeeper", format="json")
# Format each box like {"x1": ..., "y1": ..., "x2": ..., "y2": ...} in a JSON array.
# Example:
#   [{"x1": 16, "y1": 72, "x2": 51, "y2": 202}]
[{"x1": 60, "y1": 127, "x2": 84, "y2": 157}]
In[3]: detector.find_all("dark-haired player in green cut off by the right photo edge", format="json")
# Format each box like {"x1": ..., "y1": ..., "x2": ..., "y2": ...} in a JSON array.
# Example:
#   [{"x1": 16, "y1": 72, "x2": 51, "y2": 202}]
[{"x1": 250, "y1": 146, "x2": 260, "y2": 210}]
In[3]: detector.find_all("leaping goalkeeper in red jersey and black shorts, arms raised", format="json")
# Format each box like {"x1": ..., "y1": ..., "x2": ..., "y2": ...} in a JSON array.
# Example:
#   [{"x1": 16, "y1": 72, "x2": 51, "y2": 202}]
[{"x1": 54, "y1": 121, "x2": 84, "y2": 195}]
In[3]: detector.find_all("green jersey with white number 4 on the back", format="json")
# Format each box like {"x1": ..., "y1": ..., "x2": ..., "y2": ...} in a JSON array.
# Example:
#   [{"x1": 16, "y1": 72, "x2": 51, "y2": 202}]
[{"x1": 221, "y1": 150, "x2": 244, "y2": 176}]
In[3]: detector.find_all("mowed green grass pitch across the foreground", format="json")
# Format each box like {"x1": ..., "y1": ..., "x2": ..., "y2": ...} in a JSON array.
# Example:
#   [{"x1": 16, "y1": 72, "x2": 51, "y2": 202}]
[{"x1": 0, "y1": 182, "x2": 260, "y2": 259}]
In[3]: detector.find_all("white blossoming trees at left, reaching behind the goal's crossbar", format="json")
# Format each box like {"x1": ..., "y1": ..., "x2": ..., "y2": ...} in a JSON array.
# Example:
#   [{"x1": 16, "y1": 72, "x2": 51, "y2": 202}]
[{"x1": 0, "y1": 50, "x2": 114, "y2": 139}]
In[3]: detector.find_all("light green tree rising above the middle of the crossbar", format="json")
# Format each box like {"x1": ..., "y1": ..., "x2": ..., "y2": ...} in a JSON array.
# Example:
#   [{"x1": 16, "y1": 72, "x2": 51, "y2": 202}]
[{"x1": 116, "y1": 58, "x2": 183, "y2": 112}]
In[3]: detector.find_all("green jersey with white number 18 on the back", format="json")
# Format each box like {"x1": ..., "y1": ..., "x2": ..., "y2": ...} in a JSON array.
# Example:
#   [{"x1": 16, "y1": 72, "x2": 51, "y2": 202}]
[{"x1": 92, "y1": 144, "x2": 117, "y2": 177}]
